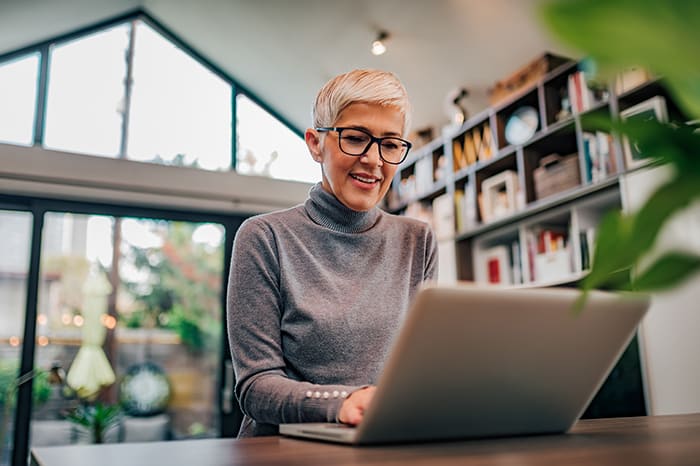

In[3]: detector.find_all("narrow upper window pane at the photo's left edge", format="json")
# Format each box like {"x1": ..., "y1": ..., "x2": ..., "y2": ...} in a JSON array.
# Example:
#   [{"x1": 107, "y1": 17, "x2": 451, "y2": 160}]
[{"x1": 0, "y1": 53, "x2": 39, "y2": 146}]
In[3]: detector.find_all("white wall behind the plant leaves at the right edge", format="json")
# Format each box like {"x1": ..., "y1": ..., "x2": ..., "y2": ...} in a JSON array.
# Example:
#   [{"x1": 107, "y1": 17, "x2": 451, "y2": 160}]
[{"x1": 623, "y1": 167, "x2": 700, "y2": 414}]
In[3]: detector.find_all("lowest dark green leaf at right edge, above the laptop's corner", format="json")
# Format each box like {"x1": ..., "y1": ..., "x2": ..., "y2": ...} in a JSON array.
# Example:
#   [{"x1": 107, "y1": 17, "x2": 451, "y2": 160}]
[{"x1": 632, "y1": 252, "x2": 700, "y2": 291}]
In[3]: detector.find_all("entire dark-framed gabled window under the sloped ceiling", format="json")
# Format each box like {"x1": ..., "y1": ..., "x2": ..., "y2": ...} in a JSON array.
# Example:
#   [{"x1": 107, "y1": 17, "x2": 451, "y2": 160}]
[{"x1": 0, "y1": 12, "x2": 320, "y2": 182}]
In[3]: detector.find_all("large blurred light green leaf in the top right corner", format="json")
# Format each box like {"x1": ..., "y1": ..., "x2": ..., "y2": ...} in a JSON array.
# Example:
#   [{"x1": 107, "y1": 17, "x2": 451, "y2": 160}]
[{"x1": 542, "y1": 0, "x2": 700, "y2": 118}]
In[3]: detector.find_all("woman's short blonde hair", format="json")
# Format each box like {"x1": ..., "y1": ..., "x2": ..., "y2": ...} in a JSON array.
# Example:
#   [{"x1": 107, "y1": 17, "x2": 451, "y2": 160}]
[{"x1": 312, "y1": 70, "x2": 411, "y2": 135}]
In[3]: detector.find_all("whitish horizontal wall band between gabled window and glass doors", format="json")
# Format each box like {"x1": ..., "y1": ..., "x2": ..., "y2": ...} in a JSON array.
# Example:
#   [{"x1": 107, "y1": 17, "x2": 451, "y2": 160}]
[{"x1": 0, "y1": 144, "x2": 311, "y2": 213}]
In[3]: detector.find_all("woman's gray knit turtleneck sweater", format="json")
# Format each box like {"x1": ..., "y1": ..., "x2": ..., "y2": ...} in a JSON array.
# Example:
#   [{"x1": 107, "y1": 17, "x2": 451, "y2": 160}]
[{"x1": 227, "y1": 184, "x2": 437, "y2": 437}]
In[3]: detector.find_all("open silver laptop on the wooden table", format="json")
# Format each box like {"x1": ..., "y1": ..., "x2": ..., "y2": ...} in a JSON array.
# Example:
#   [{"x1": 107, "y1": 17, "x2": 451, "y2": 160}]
[{"x1": 280, "y1": 284, "x2": 649, "y2": 445}]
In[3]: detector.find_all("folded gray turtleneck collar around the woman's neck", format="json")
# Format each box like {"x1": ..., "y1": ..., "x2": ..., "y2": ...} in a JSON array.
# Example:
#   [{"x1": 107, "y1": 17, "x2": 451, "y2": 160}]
[{"x1": 304, "y1": 183, "x2": 381, "y2": 233}]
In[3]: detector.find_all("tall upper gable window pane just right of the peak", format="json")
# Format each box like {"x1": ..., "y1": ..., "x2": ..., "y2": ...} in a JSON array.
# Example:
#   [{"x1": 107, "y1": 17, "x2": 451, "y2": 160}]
[{"x1": 127, "y1": 21, "x2": 232, "y2": 170}]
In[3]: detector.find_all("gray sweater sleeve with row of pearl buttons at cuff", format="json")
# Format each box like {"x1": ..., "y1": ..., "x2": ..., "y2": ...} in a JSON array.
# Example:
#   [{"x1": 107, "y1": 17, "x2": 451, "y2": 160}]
[{"x1": 227, "y1": 218, "x2": 360, "y2": 425}]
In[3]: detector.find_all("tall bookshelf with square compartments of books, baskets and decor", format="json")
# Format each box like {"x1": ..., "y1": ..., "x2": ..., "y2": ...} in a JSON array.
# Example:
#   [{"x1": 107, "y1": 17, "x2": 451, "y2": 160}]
[{"x1": 386, "y1": 57, "x2": 683, "y2": 286}]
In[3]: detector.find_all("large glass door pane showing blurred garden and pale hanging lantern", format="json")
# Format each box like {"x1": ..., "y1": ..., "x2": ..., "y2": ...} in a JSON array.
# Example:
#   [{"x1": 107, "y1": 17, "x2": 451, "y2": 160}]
[{"x1": 31, "y1": 213, "x2": 224, "y2": 446}]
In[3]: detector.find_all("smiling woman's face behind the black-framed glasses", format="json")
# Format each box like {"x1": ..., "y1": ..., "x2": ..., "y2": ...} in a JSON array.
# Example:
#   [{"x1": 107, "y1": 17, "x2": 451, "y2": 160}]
[{"x1": 305, "y1": 103, "x2": 404, "y2": 211}]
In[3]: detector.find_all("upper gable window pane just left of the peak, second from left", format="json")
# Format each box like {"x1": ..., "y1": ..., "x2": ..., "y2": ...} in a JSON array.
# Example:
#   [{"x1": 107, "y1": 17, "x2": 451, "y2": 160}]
[{"x1": 44, "y1": 23, "x2": 131, "y2": 157}]
